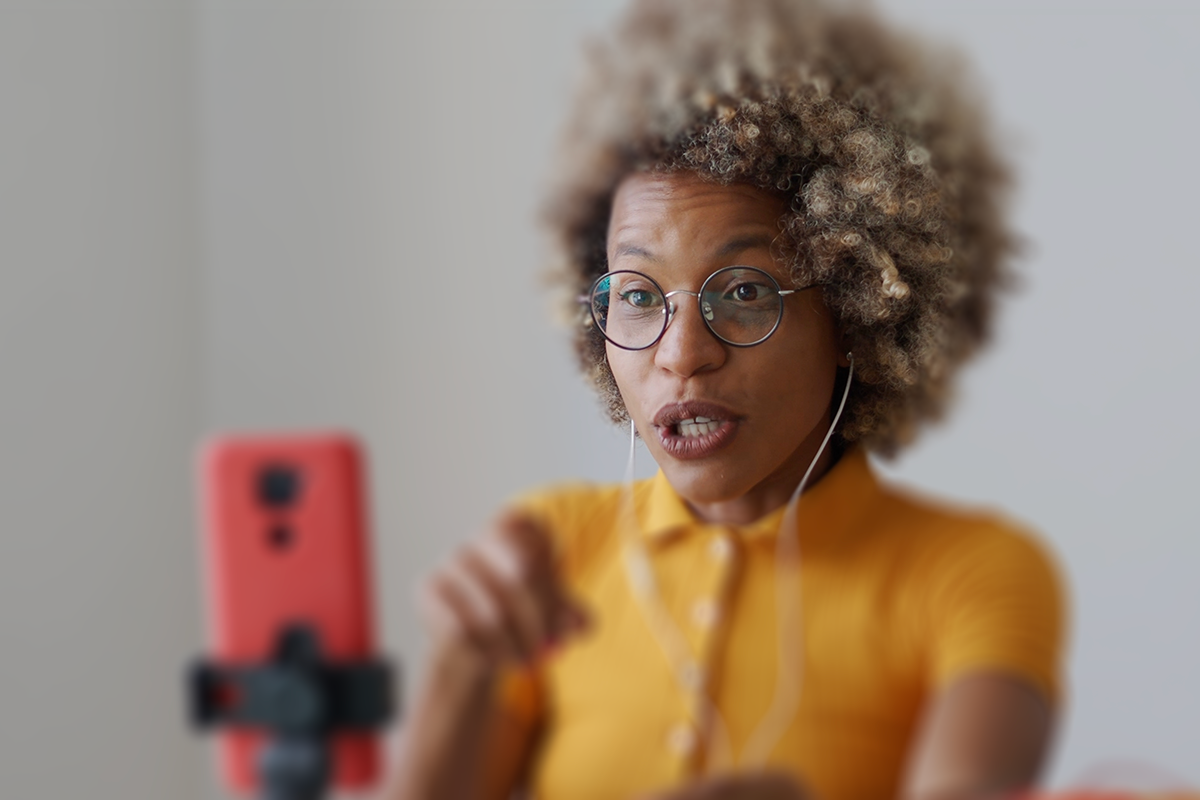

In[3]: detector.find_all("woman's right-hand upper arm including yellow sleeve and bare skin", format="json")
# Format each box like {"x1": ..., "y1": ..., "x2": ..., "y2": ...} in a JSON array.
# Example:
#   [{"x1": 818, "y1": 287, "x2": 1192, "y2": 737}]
[{"x1": 900, "y1": 525, "x2": 1066, "y2": 800}]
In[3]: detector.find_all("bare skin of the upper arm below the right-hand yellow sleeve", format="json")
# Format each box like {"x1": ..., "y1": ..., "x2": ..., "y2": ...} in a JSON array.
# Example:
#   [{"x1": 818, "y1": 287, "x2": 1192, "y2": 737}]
[{"x1": 901, "y1": 672, "x2": 1054, "y2": 800}]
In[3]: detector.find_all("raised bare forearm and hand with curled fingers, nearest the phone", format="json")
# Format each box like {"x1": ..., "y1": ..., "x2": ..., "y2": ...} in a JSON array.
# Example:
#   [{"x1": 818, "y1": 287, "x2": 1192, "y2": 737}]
[{"x1": 388, "y1": 513, "x2": 583, "y2": 800}]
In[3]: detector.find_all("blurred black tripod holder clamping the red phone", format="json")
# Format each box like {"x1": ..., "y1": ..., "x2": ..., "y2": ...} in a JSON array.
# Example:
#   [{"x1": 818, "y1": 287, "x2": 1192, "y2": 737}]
[{"x1": 190, "y1": 625, "x2": 392, "y2": 800}]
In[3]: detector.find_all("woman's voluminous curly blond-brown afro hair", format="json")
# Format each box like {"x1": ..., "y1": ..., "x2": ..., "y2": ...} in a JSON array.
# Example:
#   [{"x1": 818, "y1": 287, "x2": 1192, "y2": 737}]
[{"x1": 545, "y1": 0, "x2": 1015, "y2": 456}]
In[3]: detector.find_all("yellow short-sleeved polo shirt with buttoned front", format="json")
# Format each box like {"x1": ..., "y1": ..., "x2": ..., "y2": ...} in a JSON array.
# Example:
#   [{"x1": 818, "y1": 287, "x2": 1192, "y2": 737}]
[{"x1": 499, "y1": 450, "x2": 1063, "y2": 800}]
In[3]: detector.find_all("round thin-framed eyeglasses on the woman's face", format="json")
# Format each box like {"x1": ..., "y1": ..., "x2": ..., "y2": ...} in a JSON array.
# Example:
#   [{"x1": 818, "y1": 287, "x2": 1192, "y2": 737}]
[{"x1": 580, "y1": 266, "x2": 809, "y2": 350}]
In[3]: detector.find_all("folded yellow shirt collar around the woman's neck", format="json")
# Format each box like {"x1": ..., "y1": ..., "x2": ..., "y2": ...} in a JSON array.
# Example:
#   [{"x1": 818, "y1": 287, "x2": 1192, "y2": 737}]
[{"x1": 636, "y1": 447, "x2": 878, "y2": 543}]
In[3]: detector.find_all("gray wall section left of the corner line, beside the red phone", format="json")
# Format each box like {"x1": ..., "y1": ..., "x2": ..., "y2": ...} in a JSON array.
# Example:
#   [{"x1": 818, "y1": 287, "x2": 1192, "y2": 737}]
[{"x1": 0, "y1": 0, "x2": 203, "y2": 800}]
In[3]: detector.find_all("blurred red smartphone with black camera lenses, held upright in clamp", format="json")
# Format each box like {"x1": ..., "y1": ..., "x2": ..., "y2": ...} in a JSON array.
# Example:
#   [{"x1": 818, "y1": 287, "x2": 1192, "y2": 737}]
[{"x1": 200, "y1": 433, "x2": 379, "y2": 793}]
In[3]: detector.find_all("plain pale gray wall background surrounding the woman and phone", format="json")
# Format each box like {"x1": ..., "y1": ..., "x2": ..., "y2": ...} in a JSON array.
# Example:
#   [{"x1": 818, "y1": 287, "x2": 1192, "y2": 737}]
[{"x1": 0, "y1": 0, "x2": 1200, "y2": 800}]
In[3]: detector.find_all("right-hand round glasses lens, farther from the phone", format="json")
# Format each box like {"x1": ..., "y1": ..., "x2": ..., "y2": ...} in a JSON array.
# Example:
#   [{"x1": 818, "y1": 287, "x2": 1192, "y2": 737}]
[{"x1": 700, "y1": 266, "x2": 784, "y2": 344}]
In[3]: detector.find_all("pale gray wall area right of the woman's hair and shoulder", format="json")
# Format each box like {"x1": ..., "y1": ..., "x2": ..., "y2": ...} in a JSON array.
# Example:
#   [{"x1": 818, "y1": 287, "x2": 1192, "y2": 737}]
[{"x1": 864, "y1": 0, "x2": 1200, "y2": 788}]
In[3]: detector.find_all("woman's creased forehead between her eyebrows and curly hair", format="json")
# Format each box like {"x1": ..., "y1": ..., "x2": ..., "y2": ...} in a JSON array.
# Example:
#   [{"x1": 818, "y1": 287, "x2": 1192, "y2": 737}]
[{"x1": 608, "y1": 173, "x2": 787, "y2": 255}]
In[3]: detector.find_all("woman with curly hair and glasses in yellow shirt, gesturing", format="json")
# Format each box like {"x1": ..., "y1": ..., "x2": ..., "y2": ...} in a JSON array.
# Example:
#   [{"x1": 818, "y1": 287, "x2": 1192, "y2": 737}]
[{"x1": 395, "y1": 0, "x2": 1062, "y2": 800}]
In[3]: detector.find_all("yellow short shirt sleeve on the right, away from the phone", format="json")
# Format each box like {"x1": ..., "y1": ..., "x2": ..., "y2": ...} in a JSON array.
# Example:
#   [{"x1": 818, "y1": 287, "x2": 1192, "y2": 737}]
[{"x1": 926, "y1": 524, "x2": 1067, "y2": 704}]
